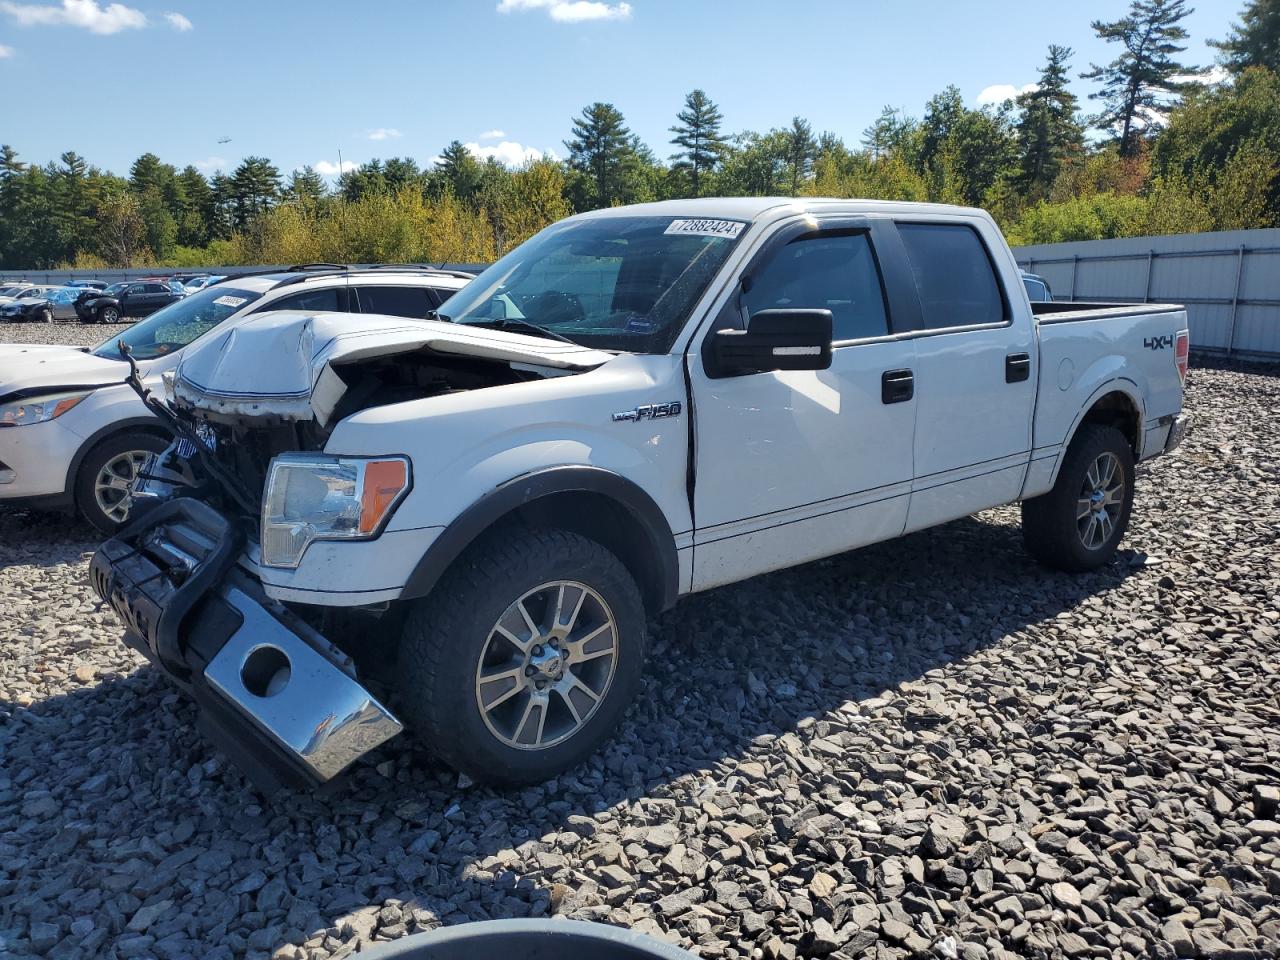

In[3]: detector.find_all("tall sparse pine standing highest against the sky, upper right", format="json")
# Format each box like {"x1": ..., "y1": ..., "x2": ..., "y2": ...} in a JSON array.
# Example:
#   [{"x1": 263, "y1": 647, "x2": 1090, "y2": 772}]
[{"x1": 1080, "y1": 0, "x2": 1196, "y2": 156}]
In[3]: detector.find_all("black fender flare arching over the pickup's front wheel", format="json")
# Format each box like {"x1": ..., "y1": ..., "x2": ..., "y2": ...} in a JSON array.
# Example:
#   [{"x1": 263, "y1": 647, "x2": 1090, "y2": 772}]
[{"x1": 401, "y1": 465, "x2": 680, "y2": 609}]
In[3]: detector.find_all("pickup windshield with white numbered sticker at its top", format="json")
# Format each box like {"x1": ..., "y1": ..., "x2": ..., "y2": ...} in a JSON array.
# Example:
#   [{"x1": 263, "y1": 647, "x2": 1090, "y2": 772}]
[{"x1": 440, "y1": 216, "x2": 746, "y2": 353}]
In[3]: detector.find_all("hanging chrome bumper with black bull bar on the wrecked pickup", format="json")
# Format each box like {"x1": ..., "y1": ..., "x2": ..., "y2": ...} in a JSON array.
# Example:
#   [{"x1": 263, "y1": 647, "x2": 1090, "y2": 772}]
[{"x1": 90, "y1": 499, "x2": 402, "y2": 790}]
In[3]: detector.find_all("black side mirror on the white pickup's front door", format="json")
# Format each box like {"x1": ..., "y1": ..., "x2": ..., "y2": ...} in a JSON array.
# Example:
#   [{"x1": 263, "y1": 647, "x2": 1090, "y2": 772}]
[{"x1": 707, "y1": 310, "x2": 832, "y2": 379}]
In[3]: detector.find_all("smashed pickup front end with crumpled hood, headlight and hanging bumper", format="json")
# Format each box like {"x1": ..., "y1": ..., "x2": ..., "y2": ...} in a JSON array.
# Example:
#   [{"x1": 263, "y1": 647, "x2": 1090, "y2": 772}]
[{"x1": 90, "y1": 312, "x2": 608, "y2": 791}]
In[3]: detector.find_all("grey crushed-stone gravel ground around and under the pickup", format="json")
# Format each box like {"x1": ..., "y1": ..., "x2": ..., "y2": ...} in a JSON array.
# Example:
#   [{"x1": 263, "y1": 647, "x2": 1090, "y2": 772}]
[{"x1": 0, "y1": 328, "x2": 1280, "y2": 960}]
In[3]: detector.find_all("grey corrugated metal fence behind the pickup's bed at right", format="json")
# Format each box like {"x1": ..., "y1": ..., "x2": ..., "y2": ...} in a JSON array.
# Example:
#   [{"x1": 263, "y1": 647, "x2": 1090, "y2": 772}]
[{"x1": 1014, "y1": 229, "x2": 1280, "y2": 358}]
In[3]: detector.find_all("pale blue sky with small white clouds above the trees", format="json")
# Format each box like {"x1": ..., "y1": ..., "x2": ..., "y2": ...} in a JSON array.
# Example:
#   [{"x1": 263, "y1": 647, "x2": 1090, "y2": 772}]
[{"x1": 0, "y1": 0, "x2": 1242, "y2": 180}]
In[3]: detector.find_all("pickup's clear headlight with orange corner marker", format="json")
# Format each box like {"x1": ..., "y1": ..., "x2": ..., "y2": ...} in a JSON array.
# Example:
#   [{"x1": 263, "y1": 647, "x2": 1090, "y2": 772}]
[{"x1": 262, "y1": 453, "x2": 410, "y2": 567}]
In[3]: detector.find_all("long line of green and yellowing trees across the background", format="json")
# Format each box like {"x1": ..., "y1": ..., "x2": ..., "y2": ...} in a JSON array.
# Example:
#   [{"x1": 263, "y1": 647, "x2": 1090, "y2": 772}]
[{"x1": 0, "y1": 0, "x2": 1280, "y2": 269}]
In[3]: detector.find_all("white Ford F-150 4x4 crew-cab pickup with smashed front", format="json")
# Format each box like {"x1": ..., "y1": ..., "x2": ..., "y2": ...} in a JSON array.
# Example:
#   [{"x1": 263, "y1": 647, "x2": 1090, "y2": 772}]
[{"x1": 92, "y1": 198, "x2": 1188, "y2": 783}]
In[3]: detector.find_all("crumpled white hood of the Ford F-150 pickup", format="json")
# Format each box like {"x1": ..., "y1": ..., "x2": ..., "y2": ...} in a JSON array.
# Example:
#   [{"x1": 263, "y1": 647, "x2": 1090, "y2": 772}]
[{"x1": 174, "y1": 310, "x2": 613, "y2": 424}]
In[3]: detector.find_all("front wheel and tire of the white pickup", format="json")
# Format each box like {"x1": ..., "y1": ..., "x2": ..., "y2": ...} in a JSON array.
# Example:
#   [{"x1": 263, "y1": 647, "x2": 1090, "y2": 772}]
[{"x1": 399, "y1": 526, "x2": 645, "y2": 785}]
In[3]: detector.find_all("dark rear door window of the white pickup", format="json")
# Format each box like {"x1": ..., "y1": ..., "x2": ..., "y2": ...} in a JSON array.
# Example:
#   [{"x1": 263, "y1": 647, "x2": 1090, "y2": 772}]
[{"x1": 899, "y1": 223, "x2": 1005, "y2": 330}]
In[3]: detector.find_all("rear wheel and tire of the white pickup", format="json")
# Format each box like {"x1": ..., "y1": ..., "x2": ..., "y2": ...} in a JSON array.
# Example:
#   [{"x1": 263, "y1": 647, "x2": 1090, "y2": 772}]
[{"x1": 1023, "y1": 424, "x2": 1134, "y2": 573}]
